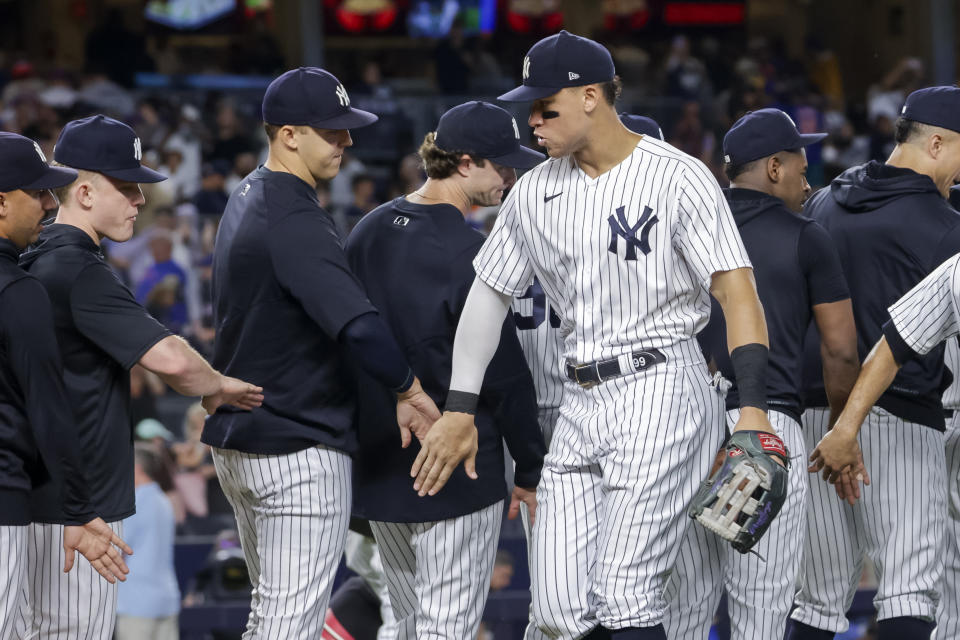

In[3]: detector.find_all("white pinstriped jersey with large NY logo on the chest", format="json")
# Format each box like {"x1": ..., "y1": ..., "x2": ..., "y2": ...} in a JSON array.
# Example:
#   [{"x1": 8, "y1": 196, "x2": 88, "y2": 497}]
[{"x1": 474, "y1": 137, "x2": 750, "y2": 362}]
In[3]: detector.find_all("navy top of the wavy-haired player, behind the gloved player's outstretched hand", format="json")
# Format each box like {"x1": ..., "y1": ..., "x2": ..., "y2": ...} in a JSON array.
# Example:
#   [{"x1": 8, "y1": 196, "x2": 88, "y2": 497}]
[{"x1": 346, "y1": 198, "x2": 546, "y2": 522}]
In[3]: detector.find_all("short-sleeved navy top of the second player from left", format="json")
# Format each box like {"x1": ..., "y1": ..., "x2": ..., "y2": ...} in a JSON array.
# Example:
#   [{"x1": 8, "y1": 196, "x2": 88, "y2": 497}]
[{"x1": 20, "y1": 224, "x2": 170, "y2": 522}]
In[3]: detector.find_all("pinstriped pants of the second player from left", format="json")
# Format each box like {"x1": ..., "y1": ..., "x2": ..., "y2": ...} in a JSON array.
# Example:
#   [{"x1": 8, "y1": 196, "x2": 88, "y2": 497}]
[{"x1": 21, "y1": 521, "x2": 123, "y2": 640}]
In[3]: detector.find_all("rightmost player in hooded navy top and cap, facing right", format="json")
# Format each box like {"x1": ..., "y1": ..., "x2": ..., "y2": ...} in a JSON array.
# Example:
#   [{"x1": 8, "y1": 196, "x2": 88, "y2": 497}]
[{"x1": 789, "y1": 87, "x2": 960, "y2": 640}]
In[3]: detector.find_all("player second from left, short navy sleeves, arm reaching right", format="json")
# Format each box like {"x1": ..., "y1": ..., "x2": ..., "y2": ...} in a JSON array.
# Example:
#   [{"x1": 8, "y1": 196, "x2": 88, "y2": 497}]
[{"x1": 20, "y1": 115, "x2": 261, "y2": 639}]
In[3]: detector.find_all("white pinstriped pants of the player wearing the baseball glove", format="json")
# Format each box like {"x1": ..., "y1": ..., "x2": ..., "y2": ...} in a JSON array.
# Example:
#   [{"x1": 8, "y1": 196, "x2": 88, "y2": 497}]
[{"x1": 531, "y1": 342, "x2": 724, "y2": 640}]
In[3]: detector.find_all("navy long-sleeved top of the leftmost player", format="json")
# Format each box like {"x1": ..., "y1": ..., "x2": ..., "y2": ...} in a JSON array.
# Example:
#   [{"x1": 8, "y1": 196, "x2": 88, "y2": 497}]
[{"x1": 0, "y1": 238, "x2": 96, "y2": 526}]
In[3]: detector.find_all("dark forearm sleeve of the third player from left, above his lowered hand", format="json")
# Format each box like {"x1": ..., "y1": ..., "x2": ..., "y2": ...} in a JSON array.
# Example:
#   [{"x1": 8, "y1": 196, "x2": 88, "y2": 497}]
[{"x1": 338, "y1": 311, "x2": 413, "y2": 393}]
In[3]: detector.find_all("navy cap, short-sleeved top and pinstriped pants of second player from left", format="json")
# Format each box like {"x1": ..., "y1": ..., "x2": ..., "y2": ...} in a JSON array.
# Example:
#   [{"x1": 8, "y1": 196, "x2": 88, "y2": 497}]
[{"x1": 20, "y1": 116, "x2": 170, "y2": 639}]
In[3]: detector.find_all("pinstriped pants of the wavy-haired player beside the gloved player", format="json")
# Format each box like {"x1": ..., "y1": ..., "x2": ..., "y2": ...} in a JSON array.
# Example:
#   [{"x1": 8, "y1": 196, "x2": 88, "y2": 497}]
[{"x1": 370, "y1": 500, "x2": 503, "y2": 640}]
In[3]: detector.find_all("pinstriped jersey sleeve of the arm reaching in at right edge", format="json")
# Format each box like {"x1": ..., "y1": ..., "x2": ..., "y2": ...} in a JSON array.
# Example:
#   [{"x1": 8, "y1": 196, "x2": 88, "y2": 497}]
[{"x1": 884, "y1": 254, "x2": 960, "y2": 355}]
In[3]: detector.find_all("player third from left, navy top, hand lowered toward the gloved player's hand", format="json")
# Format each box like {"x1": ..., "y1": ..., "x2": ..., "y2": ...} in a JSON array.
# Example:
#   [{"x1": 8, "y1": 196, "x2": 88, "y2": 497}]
[{"x1": 202, "y1": 67, "x2": 439, "y2": 640}]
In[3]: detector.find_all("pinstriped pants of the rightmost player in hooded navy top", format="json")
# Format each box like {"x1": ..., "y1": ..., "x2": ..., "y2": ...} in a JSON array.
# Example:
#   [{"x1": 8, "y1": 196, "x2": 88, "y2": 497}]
[{"x1": 791, "y1": 407, "x2": 947, "y2": 632}]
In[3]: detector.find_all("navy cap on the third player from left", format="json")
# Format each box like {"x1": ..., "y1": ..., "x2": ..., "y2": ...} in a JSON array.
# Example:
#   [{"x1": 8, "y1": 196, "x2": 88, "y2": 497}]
[{"x1": 263, "y1": 67, "x2": 377, "y2": 129}]
